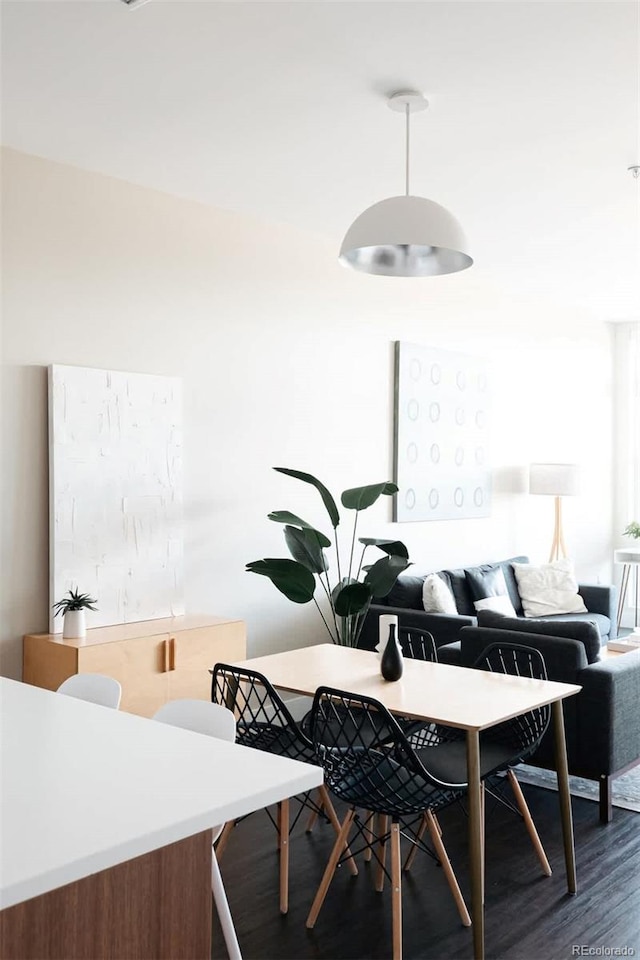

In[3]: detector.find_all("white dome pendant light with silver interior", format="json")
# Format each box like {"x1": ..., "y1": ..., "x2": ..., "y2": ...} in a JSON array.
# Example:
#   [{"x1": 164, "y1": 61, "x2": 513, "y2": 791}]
[{"x1": 339, "y1": 90, "x2": 473, "y2": 277}]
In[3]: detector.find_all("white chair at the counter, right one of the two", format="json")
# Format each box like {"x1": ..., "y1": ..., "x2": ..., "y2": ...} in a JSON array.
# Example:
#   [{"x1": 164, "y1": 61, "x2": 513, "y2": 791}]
[{"x1": 153, "y1": 699, "x2": 242, "y2": 960}]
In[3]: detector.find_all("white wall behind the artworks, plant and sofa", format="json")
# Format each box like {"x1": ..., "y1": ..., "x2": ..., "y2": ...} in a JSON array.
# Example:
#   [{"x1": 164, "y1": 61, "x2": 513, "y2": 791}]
[{"x1": 0, "y1": 150, "x2": 612, "y2": 676}]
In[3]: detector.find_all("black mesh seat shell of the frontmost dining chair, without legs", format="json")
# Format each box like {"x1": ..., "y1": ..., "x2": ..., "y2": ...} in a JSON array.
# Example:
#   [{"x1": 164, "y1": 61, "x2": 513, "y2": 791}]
[{"x1": 310, "y1": 687, "x2": 466, "y2": 819}]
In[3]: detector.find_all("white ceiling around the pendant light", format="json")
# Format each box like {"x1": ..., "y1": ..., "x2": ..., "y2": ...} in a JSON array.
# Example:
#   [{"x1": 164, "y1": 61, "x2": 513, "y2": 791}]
[{"x1": 2, "y1": 0, "x2": 640, "y2": 319}]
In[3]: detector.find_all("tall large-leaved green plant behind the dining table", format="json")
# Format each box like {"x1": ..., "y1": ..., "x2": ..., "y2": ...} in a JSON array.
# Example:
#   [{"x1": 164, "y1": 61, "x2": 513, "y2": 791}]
[{"x1": 247, "y1": 467, "x2": 410, "y2": 647}]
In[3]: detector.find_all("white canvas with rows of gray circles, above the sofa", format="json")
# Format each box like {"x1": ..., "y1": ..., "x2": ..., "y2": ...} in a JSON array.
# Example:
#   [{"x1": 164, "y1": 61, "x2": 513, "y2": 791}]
[{"x1": 394, "y1": 341, "x2": 491, "y2": 522}]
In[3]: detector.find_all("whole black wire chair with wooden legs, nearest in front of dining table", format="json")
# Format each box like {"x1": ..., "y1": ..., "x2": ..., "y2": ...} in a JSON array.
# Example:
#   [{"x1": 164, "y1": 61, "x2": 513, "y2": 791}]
[{"x1": 307, "y1": 687, "x2": 471, "y2": 960}]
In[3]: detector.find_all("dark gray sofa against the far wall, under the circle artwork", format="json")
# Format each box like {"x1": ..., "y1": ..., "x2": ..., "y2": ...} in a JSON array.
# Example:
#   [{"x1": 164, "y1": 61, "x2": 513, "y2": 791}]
[{"x1": 358, "y1": 556, "x2": 616, "y2": 650}]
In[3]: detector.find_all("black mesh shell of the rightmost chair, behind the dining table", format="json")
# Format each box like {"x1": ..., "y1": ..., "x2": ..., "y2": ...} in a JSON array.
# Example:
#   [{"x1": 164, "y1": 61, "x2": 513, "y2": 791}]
[{"x1": 473, "y1": 642, "x2": 551, "y2": 763}]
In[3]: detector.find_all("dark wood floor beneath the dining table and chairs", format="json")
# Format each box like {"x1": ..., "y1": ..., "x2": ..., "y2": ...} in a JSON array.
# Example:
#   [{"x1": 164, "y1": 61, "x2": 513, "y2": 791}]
[{"x1": 212, "y1": 786, "x2": 640, "y2": 960}]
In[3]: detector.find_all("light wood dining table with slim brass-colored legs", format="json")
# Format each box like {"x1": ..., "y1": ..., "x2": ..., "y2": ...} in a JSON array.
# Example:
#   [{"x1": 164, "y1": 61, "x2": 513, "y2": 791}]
[{"x1": 236, "y1": 643, "x2": 582, "y2": 960}]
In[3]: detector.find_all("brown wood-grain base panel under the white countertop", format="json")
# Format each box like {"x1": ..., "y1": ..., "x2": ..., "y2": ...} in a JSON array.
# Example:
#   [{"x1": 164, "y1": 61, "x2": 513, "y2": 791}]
[{"x1": 0, "y1": 830, "x2": 212, "y2": 960}]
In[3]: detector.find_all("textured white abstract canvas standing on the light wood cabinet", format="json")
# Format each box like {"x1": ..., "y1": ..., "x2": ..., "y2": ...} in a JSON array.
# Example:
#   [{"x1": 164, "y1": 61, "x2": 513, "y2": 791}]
[{"x1": 49, "y1": 364, "x2": 184, "y2": 632}]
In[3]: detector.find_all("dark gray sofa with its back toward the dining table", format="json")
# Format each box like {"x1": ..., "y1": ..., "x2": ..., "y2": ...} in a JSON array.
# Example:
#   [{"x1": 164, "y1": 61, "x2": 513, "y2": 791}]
[{"x1": 438, "y1": 611, "x2": 640, "y2": 823}]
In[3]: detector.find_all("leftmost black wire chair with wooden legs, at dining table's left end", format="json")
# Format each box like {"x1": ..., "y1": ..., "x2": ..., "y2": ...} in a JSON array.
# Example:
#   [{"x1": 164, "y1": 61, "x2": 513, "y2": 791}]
[{"x1": 211, "y1": 663, "x2": 358, "y2": 913}]
